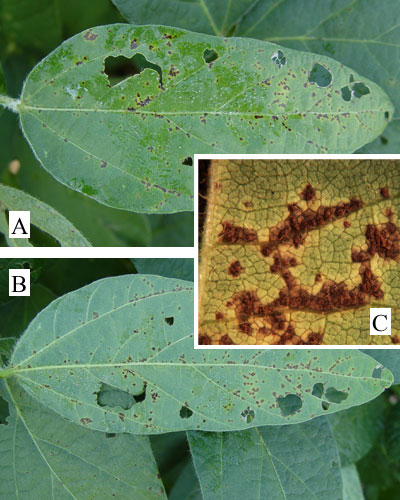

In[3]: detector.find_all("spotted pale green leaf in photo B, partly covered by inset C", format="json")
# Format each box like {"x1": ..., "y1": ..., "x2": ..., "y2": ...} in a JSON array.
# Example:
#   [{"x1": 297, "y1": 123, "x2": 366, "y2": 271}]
[{"x1": 0, "y1": 275, "x2": 392, "y2": 434}]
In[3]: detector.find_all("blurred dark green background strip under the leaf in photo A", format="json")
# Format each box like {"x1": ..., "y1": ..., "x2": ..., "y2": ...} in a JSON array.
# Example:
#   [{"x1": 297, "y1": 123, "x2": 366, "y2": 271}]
[{"x1": 0, "y1": 112, "x2": 193, "y2": 246}]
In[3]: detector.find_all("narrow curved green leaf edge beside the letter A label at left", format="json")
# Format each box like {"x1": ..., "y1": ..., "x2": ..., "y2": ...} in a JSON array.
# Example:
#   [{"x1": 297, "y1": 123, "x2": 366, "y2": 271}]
[{"x1": 0, "y1": 184, "x2": 90, "y2": 247}]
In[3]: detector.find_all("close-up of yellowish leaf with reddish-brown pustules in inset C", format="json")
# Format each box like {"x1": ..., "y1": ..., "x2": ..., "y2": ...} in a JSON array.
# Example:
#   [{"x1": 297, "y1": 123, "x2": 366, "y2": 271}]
[{"x1": 199, "y1": 160, "x2": 400, "y2": 345}]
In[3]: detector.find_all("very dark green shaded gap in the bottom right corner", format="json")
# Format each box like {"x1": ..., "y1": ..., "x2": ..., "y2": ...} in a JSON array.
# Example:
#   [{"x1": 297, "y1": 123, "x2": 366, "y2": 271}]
[{"x1": 357, "y1": 396, "x2": 400, "y2": 500}]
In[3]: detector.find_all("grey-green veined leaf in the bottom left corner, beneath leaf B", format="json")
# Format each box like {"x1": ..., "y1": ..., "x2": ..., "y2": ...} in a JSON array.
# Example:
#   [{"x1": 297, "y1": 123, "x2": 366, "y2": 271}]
[{"x1": 0, "y1": 382, "x2": 166, "y2": 500}]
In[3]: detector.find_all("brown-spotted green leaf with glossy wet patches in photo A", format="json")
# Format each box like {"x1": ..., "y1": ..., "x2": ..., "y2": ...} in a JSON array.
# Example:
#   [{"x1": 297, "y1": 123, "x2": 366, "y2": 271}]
[{"x1": 17, "y1": 24, "x2": 392, "y2": 213}]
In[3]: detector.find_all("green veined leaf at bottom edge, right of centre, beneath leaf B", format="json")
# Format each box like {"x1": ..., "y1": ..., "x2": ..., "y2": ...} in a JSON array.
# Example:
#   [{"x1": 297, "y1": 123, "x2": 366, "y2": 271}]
[{"x1": 188, "y1": 417, "x2": 342, "y2": 500}]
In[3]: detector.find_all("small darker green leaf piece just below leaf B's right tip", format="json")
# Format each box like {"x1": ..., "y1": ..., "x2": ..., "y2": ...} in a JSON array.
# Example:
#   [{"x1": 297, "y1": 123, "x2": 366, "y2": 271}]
[{"x1": 329, "y1": 396, "x2": 385, "y2": 466}]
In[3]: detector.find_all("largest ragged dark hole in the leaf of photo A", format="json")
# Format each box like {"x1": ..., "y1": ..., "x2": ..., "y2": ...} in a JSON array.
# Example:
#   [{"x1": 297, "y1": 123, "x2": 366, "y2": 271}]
[{"x1": 104, "y1": 54, "x2": 162, "y2": 87}]
